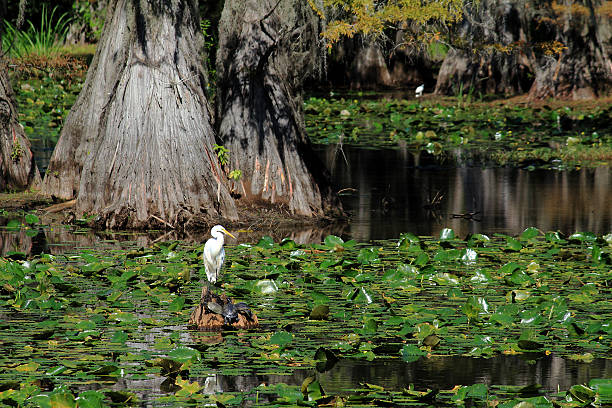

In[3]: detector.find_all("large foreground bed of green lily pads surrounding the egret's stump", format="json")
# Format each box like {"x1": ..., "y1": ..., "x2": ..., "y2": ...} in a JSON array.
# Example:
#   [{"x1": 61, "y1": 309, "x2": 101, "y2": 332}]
[{"x1": 0, "y1": 218, "x2": 612, "y2": 407}]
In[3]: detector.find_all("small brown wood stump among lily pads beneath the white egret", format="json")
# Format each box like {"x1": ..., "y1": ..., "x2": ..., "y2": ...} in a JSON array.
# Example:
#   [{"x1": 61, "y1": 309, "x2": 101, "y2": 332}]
[{"x1": 189, "y1": 286, "x2": 259, "y2": 331}]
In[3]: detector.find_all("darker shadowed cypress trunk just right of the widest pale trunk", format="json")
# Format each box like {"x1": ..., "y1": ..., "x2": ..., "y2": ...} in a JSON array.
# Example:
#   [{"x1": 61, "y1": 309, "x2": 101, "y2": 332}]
[{"x1": 217, "y1": 0, "x2": 338, "y2": 216}]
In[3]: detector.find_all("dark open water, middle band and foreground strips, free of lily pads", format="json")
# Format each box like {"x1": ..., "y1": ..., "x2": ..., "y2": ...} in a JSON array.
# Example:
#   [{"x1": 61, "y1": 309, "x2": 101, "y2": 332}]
[{"x1": 0, "y1": 146, "x2": 612, "y2": 400}]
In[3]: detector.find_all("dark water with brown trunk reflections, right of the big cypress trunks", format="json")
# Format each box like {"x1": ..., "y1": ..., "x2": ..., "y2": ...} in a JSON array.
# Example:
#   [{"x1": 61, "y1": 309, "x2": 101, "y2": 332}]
[{"x1": 321, "y1": 146, "x2": 612, "y2": 241}]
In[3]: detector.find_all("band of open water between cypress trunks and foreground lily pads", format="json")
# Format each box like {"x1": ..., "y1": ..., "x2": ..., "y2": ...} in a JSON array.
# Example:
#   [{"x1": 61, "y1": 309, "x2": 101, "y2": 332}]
[{"x1": 0, "y1": 146, "x2": 612, "y2": 255}]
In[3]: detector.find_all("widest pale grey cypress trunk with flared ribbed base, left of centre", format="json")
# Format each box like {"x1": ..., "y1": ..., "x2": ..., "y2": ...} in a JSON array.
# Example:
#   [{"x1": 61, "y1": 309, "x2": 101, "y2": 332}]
[{"x1": 45, "y1": 0, "x2": 237, "y2": 228}]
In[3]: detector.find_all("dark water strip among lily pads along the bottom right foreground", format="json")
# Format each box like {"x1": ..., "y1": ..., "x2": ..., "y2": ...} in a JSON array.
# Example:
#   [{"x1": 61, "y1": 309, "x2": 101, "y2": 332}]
[{"x1": 197, "y1": 355, "x2": 612, "y2": 395}]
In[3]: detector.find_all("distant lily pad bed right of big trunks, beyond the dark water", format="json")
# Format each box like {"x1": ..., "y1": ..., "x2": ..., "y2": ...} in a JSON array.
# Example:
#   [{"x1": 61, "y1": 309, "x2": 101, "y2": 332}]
[{"x1": 305, "y1": 95, "x2": 612, "y2": 169}]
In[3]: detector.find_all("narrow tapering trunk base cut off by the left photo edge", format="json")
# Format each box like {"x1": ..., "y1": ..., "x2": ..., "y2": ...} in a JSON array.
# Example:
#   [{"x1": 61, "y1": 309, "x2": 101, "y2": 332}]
[{"x1": 0, "y1": 60, "x2": 40, "y2": 190}]
